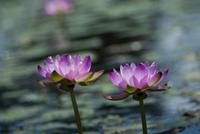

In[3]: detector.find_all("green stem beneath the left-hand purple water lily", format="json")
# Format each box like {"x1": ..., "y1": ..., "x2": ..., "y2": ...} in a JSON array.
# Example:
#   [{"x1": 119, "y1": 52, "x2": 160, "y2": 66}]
[{"x1": 69, "y1": 89, "x2": 83, "y2": 134}]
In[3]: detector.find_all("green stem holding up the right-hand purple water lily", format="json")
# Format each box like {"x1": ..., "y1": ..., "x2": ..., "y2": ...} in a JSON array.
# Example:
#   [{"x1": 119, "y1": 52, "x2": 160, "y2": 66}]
[{"x1": 139, "y1": 99, "x2": 147, "y2": 134}]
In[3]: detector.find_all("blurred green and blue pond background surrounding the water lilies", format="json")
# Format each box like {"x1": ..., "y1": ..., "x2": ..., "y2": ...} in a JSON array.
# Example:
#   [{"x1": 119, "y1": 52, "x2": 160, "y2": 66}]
[{"x1": 0, "y1": 0, "x2": 200, "y2": 134}]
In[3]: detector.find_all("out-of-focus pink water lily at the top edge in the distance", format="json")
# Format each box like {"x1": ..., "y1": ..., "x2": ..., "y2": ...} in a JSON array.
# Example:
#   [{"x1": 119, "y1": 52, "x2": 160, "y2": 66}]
[{"x1": 45, "y1": 0, "x2": 73, "y2": 16}]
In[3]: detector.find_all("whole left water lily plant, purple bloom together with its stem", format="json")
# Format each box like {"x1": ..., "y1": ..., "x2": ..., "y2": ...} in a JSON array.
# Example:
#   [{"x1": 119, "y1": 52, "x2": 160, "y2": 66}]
[{"x1": 37, "y1": 54, "x2": 103, "y2": 134}]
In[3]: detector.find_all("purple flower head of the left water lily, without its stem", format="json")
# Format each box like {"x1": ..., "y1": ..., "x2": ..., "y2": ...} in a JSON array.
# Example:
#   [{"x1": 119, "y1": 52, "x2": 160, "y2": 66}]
[{"x1": 38, "y1": 54, "x2": 103, "y2": 85}]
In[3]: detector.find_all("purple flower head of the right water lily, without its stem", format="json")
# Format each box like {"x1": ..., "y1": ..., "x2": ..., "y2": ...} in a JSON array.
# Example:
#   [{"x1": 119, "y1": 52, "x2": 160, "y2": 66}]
[{"x1": 106, "y1": 62, "x2": 168, "y2": 100}]
